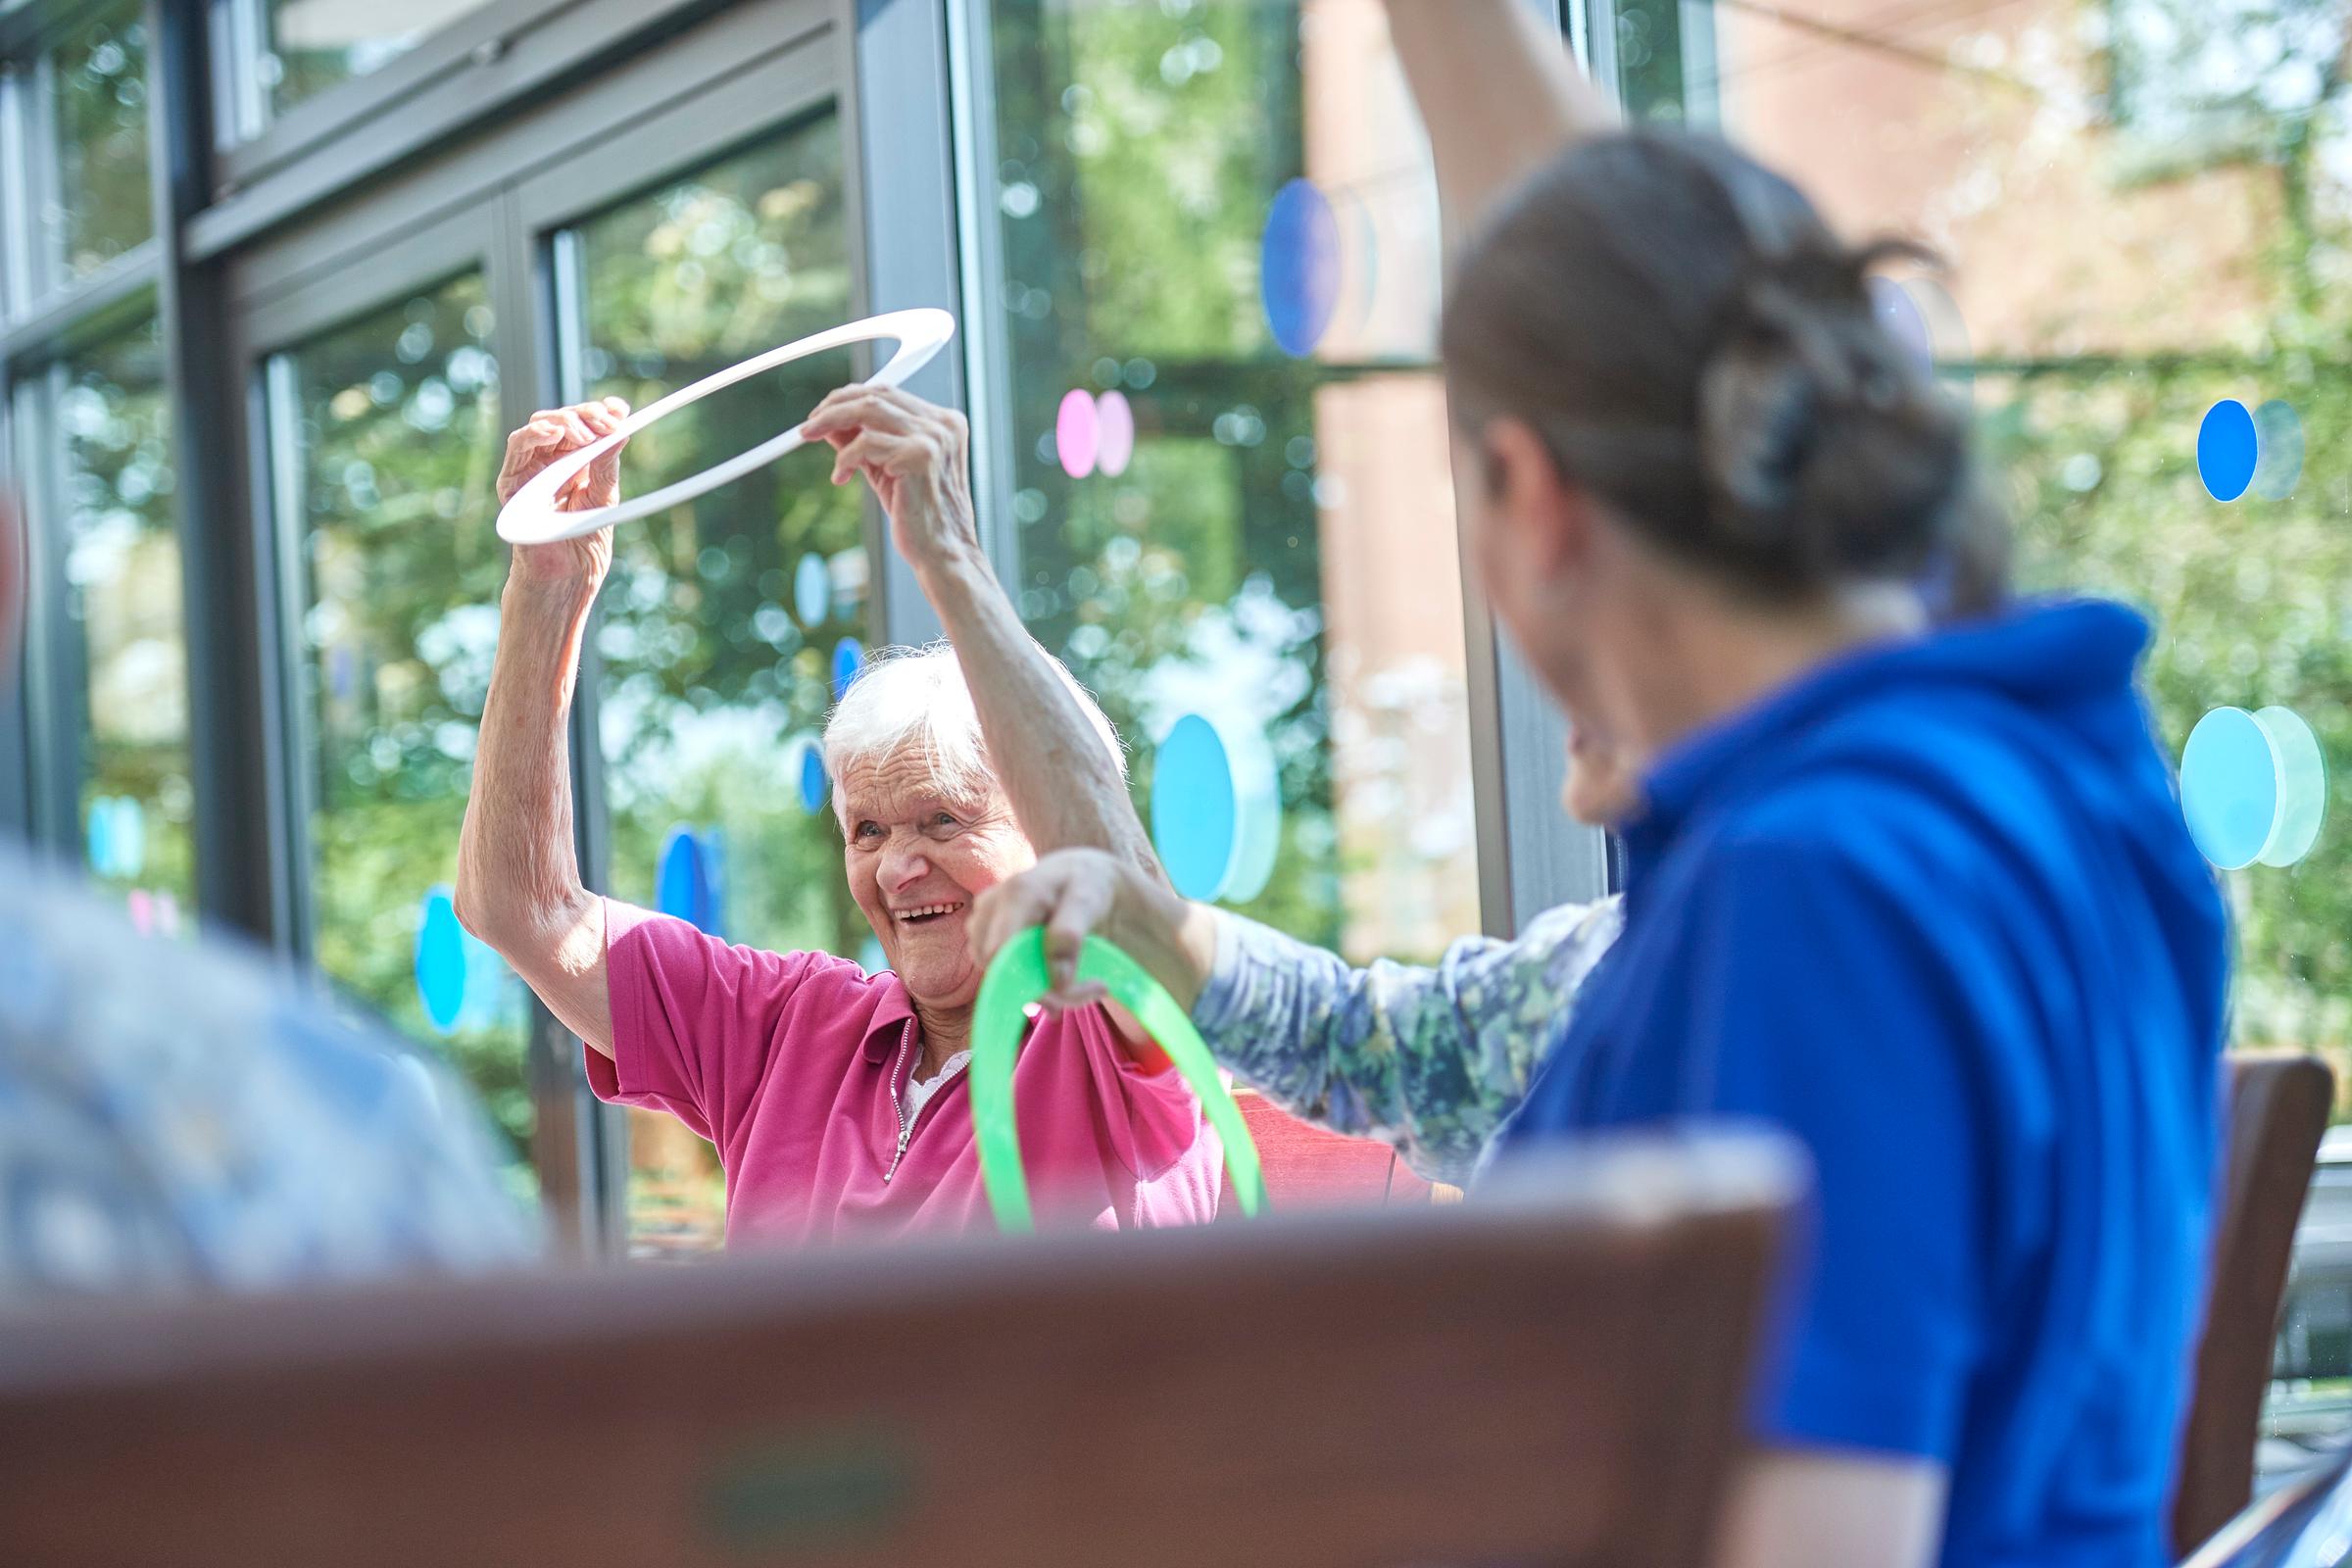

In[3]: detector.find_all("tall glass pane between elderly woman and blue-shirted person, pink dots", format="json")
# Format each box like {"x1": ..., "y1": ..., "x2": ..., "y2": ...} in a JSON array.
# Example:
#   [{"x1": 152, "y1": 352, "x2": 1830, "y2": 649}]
[{"x1": 986, "y1": 0, "x2": 1480, "y2": 959}]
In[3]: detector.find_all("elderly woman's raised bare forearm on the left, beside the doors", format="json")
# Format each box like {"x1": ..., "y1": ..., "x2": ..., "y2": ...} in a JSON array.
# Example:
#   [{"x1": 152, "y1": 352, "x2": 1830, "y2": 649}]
[{"x1": 457, "y1": 576, "x2": 612, "y2": 1054}]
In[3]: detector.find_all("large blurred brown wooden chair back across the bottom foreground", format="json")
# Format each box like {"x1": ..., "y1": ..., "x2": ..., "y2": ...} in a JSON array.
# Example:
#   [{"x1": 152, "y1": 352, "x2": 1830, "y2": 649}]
[{"x1": 0, "y1": 1133, "x2": 1804, "y2": 1568}]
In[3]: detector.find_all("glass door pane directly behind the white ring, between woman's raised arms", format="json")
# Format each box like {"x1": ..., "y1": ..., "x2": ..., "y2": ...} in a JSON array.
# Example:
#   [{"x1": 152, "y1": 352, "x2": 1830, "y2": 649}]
[{"x1": 564, "y1": 111, "x2": 872, "y2": 1253}]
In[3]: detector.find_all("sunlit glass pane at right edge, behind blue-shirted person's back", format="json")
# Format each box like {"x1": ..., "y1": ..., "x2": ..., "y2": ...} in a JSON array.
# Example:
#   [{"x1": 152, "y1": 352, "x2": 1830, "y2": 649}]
[{"x1": 1682, "y1": 0, "x2": 2352, "y2": 1457}]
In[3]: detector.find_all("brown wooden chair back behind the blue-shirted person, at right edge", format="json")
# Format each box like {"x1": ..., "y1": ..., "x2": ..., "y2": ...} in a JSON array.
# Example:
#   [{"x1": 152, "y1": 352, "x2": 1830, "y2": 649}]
[{"x1": 2174, "y1": 1055, "x2": 2335, "y2": 1556}]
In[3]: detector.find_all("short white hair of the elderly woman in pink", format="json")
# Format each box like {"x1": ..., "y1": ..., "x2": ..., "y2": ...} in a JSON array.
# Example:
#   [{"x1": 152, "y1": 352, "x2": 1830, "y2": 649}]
[{"x1": 825, "y1": 642, "x2": 1127, "y2": 827}]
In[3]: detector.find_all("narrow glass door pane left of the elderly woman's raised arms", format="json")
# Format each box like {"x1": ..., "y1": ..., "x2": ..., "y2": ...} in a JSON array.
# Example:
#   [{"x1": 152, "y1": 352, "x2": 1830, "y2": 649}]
[{"x1": 270, "y1": 275, "x2": 531, "y2": 1190}]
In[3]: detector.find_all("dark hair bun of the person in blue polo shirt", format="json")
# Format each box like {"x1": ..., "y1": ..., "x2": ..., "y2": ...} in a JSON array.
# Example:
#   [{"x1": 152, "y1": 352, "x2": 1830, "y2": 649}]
[{"x1": 1698, "y1": 244, "x2": 1966, "y2": 587}]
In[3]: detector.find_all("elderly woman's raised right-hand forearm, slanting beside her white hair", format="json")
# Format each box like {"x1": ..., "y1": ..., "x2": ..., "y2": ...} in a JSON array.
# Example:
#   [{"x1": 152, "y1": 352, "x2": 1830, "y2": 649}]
[{"x1": 917, "y1": 550, "x2": 1159, "y2": 877}]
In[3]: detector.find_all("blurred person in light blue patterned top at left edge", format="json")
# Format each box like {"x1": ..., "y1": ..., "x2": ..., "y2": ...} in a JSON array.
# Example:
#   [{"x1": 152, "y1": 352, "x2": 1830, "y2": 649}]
[{"x1": 0, "y1": 496, "x2": 539, "y2": 1304}]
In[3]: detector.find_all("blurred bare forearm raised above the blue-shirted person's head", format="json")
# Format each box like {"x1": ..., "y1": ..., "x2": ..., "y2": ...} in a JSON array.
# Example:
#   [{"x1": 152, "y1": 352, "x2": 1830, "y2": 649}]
[{"x1": 1388, "y1": 0, "x2": 1618, "y2": 232}]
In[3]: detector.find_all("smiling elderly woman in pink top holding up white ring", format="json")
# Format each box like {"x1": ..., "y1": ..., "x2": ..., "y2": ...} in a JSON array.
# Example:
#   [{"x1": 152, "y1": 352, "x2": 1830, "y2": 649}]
[{"x1": 457, "y1": 388, "x2": 1223, "y2": 1246}]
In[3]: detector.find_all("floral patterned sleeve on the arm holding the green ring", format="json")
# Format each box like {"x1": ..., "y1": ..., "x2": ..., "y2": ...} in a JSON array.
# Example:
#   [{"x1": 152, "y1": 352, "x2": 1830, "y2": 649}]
[{"x1": 1193, "y1": 898, "x2": 1621, "y2": 1180}]
